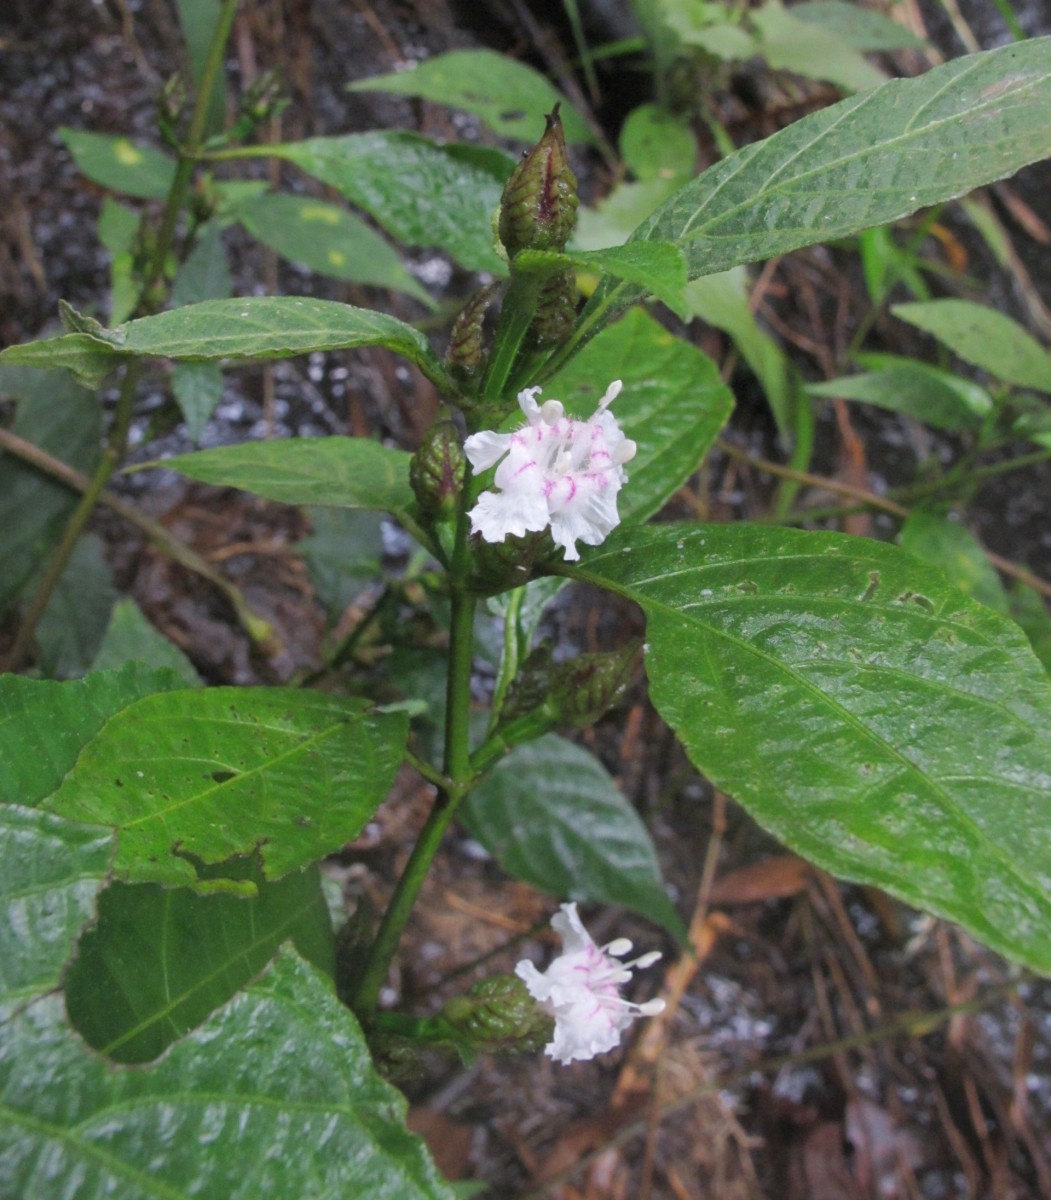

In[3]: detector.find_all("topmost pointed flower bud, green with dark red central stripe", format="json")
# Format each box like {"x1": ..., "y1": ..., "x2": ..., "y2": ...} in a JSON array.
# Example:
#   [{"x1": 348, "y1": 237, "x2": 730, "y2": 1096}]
[{"x1": 497, "y1": 104, "x2": 579, "y2": 259}]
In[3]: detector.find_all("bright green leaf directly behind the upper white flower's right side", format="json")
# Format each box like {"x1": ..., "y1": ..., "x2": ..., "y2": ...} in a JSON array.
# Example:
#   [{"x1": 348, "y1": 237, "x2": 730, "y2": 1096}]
[{"x1": 545, "y1": 308, "x2": 733, "y2": 523}]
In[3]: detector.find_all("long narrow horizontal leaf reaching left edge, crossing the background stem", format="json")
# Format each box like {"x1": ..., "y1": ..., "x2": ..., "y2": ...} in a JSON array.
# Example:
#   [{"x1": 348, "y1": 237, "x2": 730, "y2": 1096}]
[{"x1": 0, "y1": 296, "x2": 445, "y2": 391}]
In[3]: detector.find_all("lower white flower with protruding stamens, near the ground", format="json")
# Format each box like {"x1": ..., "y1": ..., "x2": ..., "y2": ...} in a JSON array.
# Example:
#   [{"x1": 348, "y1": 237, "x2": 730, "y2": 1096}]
[{"x1": 515, "y1": 904, "x2": 665, "y2": 1063}]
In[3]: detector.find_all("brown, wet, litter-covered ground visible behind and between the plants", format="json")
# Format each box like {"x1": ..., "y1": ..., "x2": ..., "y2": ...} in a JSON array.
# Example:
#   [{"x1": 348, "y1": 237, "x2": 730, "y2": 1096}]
[{"x1": 0, "y1": 0, "x2": 1051, "y2": 1200}]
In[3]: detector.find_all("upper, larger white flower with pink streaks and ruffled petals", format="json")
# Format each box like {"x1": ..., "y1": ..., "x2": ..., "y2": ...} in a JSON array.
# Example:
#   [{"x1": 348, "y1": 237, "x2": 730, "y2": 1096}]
[{"x1": 463, "y1": 379, "x2": 637, "y2": 560}]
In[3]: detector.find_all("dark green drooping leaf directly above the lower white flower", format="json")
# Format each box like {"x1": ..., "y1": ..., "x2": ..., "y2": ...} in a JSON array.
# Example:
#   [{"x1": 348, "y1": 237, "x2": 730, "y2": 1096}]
[{"x1": 458, "y1": 734, "x2": 685, "y2": 938}]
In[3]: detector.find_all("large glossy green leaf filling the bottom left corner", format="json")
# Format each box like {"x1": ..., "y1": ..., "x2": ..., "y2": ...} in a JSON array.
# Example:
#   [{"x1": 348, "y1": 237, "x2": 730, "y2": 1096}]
[{"x1": 0, "y1": 952, "x2": 452, "y2": 1200}]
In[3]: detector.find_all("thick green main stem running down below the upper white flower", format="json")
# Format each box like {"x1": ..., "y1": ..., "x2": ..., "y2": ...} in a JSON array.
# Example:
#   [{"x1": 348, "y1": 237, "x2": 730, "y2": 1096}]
[{"x1": 352, "y1": 516, "x2": 475, "y2": 1018}]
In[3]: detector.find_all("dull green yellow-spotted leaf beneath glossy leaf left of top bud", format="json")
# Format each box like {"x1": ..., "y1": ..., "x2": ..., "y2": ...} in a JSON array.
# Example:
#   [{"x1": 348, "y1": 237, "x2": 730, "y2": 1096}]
[{"x1": 238, "y1": 193, "x2": 434, "y2": 308}]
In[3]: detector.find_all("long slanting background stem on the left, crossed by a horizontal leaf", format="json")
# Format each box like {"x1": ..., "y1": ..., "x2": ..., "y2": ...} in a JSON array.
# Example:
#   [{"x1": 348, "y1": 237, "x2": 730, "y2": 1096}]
[{"x1": 5, "y1": 0, "x2": 239, "y2": 671}]
